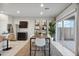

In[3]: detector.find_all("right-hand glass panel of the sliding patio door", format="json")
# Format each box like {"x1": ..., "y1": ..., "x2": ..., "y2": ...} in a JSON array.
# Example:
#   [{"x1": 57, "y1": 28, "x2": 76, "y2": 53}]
[{"x1": 63, "y1": 16, "x2": 75, "y2": 51}]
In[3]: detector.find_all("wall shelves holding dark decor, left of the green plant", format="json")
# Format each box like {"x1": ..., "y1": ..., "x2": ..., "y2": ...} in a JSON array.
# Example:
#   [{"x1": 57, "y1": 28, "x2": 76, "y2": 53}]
[{"x1": 34, "y1": 20, "x2": 47, "y2": 35}]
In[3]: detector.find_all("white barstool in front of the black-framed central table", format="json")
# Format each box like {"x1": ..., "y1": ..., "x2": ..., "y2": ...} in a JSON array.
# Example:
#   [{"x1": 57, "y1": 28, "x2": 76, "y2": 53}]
[{"x1": 35, "y1": 38, "x2": 46, "y2": 55}]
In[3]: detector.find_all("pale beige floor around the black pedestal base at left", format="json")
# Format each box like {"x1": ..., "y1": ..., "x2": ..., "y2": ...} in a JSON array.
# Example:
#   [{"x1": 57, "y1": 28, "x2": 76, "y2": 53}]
[{"x1": 0, "y1": 40, "x2": 29, "y2": 56}]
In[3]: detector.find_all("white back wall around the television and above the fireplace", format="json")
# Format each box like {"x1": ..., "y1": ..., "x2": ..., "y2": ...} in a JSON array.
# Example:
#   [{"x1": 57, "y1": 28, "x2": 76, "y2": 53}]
[{"x1": 9, "y1": 16, "x2": 53, "y2": 39}]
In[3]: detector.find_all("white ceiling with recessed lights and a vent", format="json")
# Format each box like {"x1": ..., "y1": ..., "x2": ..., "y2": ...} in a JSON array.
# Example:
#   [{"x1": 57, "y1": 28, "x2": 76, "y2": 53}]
[{"x1": 0, "y1": 3, "x2": 70, "y2": 17}]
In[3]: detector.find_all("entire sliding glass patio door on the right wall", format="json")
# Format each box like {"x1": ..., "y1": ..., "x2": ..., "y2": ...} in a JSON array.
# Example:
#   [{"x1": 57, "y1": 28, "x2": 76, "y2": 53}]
[{"x1": 56, "y1": 16, "x2": 75, "y2": 52}]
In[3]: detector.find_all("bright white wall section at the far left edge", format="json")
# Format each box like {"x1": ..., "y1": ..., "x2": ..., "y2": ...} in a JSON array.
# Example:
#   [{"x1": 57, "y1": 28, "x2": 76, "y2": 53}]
[{"x1": 0, "y1": 14, "x2": 8, "y2": 34}]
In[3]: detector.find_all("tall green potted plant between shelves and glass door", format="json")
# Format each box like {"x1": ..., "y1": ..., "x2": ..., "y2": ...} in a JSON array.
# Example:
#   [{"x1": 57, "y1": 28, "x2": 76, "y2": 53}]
[{"x1": 49, "y1": 20, "x2": 55, "y2": 41}]
